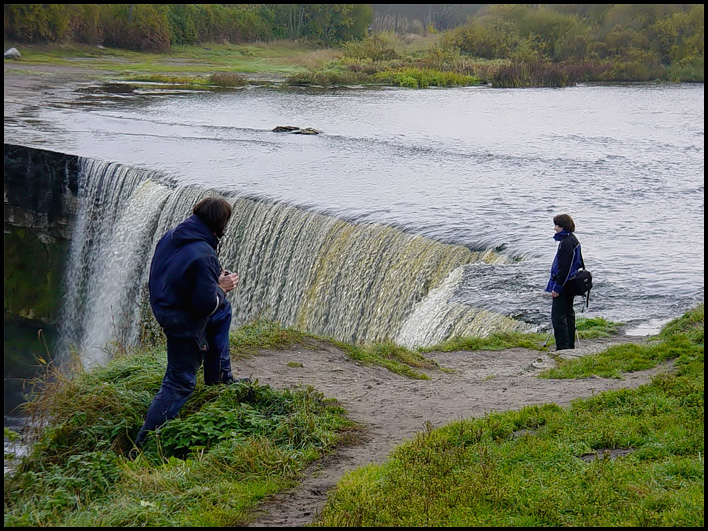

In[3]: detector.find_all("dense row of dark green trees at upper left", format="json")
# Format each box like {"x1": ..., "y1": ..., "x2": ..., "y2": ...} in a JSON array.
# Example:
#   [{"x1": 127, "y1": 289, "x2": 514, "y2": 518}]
[{"x1": 4, "y1": 4, "x2": 372, "y2": 52}]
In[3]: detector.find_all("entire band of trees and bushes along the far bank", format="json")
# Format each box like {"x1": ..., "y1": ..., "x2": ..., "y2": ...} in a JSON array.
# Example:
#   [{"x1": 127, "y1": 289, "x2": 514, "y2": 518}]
[{"x1": 4, "y1": 4, "x2": 704, "y2": 81}]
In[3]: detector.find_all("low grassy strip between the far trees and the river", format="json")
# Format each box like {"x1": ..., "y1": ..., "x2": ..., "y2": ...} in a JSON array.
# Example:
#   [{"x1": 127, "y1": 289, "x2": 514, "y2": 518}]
[{"x1": 5, "y1": 34, "x2": 703, "y2": 88}]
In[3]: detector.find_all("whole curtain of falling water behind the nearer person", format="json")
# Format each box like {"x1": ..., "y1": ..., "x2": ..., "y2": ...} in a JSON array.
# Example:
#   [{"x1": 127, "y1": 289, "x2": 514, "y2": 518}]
[{"x1": 61, "y1": 159, "x2": 521, "y2": 365}]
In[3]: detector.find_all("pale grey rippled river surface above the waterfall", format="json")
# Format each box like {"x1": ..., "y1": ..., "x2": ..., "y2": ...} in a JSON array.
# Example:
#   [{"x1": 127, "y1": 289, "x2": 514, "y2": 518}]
[{"x1": 5, "y1": 84, "x2": 704, "y2": 326}]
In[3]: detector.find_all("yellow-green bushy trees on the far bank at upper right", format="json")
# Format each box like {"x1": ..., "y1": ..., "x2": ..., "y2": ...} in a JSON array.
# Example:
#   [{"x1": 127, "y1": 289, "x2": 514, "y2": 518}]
[{"x1": 442, "y1": 4, "x2": 704, "y2": 81}]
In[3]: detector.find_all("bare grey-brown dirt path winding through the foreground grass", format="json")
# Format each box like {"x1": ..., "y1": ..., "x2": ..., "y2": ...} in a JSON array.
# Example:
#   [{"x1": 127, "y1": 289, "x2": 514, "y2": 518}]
[{"x1": 241, "y1": 337, "x2": 666, "y2": 527}]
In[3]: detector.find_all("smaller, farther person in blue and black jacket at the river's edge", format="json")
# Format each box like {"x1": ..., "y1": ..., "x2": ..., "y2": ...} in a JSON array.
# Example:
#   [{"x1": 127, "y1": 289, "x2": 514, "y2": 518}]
[{"x1": 546, "y1": 214, "x2": 583, "y2": 350}]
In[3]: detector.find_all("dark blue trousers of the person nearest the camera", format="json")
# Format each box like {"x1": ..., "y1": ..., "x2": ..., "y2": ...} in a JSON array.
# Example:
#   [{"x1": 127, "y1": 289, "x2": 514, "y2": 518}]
[{"x1": 135, "y1": 301, "x2": 233, "y2": 447}]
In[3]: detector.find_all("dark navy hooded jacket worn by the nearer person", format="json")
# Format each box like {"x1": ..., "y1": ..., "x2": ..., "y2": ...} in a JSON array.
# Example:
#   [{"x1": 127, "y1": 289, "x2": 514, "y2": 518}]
[{"x1": 149, "y1": 215, "x2": 226, "y2": 340}]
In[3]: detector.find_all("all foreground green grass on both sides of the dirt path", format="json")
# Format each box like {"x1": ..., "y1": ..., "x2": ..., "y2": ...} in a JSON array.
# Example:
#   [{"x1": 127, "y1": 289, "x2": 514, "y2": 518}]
[{"x1": 4, "y1": 305, "x2": 704, "y2": 527}]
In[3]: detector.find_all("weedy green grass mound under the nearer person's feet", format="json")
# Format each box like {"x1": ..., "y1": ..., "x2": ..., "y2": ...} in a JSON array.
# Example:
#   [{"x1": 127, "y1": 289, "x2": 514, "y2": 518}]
[{"x1": 5, "y1": 349, "x2": 352, "y2": 527}]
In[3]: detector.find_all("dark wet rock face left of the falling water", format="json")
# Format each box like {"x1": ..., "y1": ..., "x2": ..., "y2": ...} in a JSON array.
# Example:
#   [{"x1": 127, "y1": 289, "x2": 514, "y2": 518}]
[{"x1": 3, "y1": 144, "x2": 78, "y2": 323}]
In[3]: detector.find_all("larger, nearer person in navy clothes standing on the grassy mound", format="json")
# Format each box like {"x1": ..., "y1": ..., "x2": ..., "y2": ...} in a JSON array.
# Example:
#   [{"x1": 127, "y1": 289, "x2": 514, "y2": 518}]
[{"x1": 136, "y1": 197, "x2": 248, "y2": 447}]
